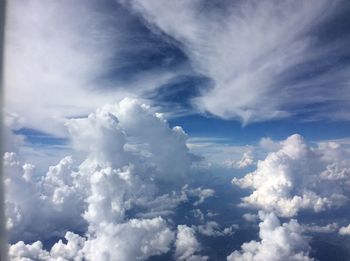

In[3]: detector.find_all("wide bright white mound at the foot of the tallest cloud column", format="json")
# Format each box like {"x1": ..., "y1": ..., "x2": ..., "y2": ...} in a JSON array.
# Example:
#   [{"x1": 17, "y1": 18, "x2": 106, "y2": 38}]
[{"x1": 83, "y1": 217, "x2": 174, "y2": 260}]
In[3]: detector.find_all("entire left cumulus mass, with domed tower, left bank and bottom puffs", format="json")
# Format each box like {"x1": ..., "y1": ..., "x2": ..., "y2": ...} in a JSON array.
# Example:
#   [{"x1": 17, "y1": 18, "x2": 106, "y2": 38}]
[{"x1": 5, "y1": 99, "x2": 213, "y2": 260}]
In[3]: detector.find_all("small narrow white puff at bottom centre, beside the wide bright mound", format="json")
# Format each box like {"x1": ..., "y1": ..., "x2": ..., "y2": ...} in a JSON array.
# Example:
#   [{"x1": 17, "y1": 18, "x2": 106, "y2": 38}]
[{"x1": 175, "y1": 225, "x2": 208, "y2": 261}]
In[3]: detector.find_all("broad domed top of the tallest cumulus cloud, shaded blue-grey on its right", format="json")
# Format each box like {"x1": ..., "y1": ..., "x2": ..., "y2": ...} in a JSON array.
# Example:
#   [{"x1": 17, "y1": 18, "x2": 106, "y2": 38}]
[{"x1": 66, "y1": 98, "x2": 192, "y2": 180}]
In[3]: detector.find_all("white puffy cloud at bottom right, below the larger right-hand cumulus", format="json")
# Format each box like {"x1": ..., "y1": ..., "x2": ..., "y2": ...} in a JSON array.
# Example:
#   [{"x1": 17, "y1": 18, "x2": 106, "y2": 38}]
[{"x1": 227, "y1": 212, "x2": 313, "y2": 261}]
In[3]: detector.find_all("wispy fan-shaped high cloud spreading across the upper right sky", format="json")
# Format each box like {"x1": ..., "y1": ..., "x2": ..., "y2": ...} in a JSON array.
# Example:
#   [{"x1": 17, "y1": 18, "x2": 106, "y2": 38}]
[{"x1": 120, "y1": 0, "x2": 349, "y2": 123}]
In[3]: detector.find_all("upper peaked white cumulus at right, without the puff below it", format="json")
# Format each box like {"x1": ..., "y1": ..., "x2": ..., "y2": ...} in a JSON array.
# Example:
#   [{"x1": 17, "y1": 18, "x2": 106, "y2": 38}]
[{"x1": 232, "y1": 135, "x2": 349, "y2": 217}]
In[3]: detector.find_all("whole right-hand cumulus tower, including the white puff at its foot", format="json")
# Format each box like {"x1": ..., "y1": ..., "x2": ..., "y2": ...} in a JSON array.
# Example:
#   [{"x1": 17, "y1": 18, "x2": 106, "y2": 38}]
[{"x1": 227, "y1": 134, "x2": 350, "y2": 261}]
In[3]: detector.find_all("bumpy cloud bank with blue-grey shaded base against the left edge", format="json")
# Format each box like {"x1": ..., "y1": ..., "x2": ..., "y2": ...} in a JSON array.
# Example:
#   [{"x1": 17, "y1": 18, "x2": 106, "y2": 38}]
[{"x1": 4, "y1": 152, "x2": 83, "y2": 240}]
